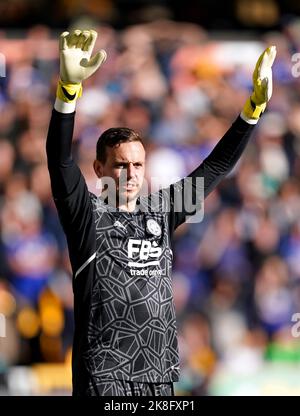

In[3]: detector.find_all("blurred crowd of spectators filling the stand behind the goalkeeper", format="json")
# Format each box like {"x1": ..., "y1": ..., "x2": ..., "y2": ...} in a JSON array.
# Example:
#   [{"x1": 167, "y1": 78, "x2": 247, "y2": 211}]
[{"x1": 0, "y1": 19, "x2": 300, "y2": 395}]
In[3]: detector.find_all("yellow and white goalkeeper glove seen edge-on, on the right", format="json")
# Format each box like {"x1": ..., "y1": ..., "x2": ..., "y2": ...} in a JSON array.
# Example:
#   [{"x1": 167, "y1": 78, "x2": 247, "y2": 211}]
[{"x1": 242, "y1": 46, "x2": 276, "y2": 123}]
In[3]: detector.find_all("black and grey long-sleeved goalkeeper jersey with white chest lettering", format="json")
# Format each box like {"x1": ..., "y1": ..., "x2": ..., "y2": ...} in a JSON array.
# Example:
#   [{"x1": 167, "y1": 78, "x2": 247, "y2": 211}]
[{"x1": 46, "y1": 110, "x2": 253, "y2": 395}]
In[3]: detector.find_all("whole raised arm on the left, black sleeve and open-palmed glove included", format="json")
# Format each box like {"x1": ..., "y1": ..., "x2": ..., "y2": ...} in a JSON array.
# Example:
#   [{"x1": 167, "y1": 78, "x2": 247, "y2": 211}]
[{"x1": 46, "y1": 30, "x2": 106, "y2": 280}]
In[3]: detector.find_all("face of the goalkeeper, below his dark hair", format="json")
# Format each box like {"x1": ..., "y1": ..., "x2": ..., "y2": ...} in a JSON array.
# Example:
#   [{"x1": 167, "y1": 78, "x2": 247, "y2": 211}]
[{"x1": 94, "y1": 141, "x2": 146, "y2": 203}]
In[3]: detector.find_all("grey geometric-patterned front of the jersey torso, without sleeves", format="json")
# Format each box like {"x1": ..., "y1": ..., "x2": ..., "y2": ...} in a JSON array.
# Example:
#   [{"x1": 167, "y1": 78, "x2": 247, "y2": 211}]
[{"x1": 84, "y1": 193, "x2": 179, "y2": 383}]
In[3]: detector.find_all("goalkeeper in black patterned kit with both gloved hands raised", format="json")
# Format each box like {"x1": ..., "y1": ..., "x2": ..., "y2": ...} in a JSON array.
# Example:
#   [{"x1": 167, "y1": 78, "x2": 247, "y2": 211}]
[{"x1": 46, "y1": 30, "x2": 276, "y2": 396}]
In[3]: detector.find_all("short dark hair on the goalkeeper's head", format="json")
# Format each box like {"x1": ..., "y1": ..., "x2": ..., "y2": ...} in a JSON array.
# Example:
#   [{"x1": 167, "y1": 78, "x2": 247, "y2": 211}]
[{"x1": 96, "y1": 127, "x2": 144, "y2": 163}]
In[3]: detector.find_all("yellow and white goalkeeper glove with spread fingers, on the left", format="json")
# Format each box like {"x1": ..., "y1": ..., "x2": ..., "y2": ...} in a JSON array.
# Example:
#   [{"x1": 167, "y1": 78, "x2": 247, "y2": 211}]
[{"x1": 56, "y1": 30, "x2": 106, "y2": 103}]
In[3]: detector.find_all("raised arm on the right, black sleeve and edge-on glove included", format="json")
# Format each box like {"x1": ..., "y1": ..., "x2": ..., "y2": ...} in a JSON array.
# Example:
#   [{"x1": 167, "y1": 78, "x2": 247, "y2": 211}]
[{"x1": 171, "y1": 46, "x2": 276, "y2": 229}]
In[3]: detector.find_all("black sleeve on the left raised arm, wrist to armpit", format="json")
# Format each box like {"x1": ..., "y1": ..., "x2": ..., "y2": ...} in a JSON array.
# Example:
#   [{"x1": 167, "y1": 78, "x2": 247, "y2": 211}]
[{"x1": 46, "y1": 109, "x2": 95, "y2": 282}]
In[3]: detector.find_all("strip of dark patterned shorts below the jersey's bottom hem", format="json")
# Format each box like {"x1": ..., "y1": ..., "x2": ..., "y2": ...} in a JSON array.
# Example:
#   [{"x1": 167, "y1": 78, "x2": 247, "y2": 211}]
[{"x1": 86, "y1": 380, "x2": 174, "y2": 396}]
